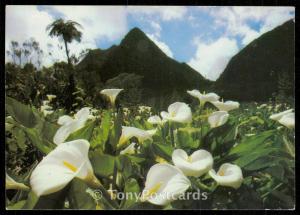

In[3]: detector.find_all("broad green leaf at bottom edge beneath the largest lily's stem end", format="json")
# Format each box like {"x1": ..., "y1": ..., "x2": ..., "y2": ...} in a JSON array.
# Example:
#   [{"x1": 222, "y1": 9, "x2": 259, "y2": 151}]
[{"x1": 68, "y1": 178, "x2": 96, "y2": 209}]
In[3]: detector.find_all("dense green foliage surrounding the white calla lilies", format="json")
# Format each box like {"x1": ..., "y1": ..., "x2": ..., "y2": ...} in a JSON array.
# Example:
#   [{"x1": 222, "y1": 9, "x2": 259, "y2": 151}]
[{"x1": 6, "y1": 93, "x2": 295, "y2": 209}]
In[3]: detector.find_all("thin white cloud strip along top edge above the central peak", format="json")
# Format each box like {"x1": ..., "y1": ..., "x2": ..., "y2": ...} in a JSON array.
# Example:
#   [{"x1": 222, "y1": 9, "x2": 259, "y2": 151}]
[{"x1": 127, "y1": 6, "x2": 187, "y2": 21}]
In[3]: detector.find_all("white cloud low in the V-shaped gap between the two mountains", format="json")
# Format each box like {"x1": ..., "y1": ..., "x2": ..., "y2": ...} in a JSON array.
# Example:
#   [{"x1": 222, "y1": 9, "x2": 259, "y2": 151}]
[{"x1": 188, "y1": 37, "x2": 238, "y2": 80}]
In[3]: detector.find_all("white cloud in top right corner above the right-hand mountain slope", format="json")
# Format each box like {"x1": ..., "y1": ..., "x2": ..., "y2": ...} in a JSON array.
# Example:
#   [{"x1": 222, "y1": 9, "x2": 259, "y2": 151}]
[{"x1": 199, "y1": 6, "x2": 295, "y2": 46}]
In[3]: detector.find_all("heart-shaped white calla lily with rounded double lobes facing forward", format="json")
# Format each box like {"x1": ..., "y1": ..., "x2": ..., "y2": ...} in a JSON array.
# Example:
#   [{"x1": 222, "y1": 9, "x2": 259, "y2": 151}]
[{"x1": 172, "y1": 149, "x2": 214, "y2": 177}]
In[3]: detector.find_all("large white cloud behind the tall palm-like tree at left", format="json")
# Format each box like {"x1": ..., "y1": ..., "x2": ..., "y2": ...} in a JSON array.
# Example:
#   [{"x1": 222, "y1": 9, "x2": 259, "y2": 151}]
[{"x1": 5, "y1": 6, "x2": 127, "y2": 66}]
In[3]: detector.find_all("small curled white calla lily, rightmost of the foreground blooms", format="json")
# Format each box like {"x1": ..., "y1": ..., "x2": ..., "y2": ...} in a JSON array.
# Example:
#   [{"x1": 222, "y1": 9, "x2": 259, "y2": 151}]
[{"x1": 209, "y1": 163, "x2": 243, "y2": 189}]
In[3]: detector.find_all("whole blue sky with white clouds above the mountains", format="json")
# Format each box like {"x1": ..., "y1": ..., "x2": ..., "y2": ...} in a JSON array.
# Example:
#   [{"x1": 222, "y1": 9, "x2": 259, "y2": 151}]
[{"x1": 6, "y1": 6, "x2": 295, "y2": 80}]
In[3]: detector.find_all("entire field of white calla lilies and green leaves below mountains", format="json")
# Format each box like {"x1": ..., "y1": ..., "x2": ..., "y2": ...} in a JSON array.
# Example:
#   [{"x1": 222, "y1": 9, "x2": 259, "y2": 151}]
[{"x1": 5, "y1": 89, "x2": 295, "y2": 210}]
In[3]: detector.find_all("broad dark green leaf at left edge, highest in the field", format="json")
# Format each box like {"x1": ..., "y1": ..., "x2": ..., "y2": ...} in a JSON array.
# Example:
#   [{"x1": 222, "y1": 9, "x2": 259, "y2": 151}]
[{"x1": 5, "y1": 96, "x2": 38, "y2": 128}]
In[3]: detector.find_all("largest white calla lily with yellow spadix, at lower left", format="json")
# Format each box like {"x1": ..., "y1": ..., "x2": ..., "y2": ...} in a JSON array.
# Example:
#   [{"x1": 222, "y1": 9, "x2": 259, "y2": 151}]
[{"x1": 30, "y1": 139, "x2": 101, "y2": 196}]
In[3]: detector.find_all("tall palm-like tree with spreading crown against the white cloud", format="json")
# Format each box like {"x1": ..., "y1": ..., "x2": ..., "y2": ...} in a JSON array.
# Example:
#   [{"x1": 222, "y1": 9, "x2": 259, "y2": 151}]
[{"x1": 46, "y1": 19, "x2": 82, "y2": 65}]
